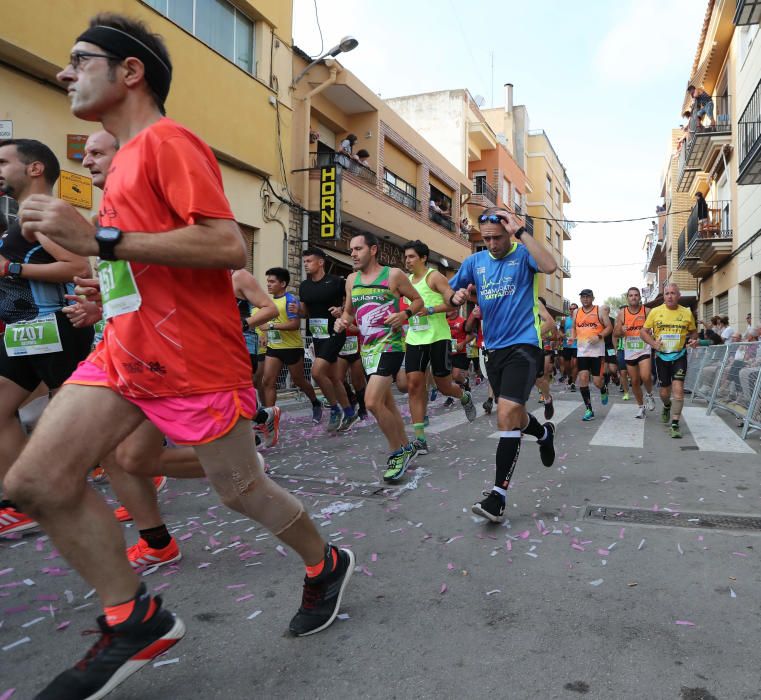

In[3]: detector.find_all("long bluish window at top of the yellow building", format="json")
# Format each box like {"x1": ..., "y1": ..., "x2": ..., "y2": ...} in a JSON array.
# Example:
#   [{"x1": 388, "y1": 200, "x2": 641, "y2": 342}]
[{"x1": 144, "y1": 0, "x2": 254, "y2": 74}]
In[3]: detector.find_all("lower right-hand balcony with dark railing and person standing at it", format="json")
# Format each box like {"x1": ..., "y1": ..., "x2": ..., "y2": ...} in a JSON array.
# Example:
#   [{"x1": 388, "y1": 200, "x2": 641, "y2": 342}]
[{"x1": 678, "y1": 200, "x2": 732, "y2": 277}]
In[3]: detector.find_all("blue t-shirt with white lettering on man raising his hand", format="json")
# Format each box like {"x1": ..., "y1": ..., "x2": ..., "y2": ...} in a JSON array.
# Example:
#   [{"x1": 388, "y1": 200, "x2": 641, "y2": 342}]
[{"x1": 449, "y1": 243, "x2": 542, "y2": 350}]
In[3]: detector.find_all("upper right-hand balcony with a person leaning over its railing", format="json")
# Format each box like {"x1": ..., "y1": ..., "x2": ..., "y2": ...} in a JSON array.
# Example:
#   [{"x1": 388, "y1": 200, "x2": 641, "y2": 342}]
[{"x1": 677, "y1": 95, "x2": 732, "y2": 192}]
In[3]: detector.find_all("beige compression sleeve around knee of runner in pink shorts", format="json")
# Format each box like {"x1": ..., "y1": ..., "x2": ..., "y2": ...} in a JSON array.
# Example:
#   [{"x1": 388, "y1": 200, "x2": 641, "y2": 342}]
[{"x1": 195, "y1": 420, "x2": 304, "y2": 535}]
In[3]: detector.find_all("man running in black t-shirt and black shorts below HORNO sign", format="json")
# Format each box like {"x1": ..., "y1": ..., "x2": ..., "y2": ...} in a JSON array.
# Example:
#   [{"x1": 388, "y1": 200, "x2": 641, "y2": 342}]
[{"x1": 296, "y1": 248, "x2": 359, "y2": 433}]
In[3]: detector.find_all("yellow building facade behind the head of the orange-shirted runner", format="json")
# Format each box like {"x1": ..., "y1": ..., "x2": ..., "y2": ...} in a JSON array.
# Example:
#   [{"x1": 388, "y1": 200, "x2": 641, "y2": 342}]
[{"x1": 0, "y1": 0, "x2": 298, "y2": 278}]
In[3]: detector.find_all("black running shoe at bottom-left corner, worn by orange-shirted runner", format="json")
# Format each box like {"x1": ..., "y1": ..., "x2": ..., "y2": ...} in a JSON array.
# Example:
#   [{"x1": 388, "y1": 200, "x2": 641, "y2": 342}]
[{"x1": 36, "y1": 583, "x2": 185, "y2": 700}]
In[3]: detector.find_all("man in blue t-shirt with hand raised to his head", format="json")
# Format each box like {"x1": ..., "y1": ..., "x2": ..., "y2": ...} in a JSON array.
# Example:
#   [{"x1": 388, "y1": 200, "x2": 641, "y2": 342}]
[{"x1": 449, "y1": 207, "x2": 557, "y2": 523}]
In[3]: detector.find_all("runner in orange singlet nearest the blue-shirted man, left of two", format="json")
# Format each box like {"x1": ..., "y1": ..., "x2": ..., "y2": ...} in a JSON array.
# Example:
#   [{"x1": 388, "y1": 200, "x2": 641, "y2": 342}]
[{"x1": 571, "y1": 289, "x2": 613, "y2": 421}]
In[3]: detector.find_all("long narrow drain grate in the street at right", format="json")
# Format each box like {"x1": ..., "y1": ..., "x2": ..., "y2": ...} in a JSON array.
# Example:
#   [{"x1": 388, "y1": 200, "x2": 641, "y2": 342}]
[{"x1": 583, "y1": 505, "x2": 761, "y2": 531}]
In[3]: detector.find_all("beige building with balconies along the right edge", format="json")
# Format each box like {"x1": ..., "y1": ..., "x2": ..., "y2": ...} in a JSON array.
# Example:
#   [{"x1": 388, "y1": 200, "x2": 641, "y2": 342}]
[{"x1": 671, "y1": 0, "x2": 761, "y2": 331}]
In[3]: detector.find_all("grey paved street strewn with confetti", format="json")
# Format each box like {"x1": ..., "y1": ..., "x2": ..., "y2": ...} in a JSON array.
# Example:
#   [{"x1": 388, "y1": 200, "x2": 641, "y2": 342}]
[{"x1": 0, "y1": 387, "x2": 761, "y2": 700}]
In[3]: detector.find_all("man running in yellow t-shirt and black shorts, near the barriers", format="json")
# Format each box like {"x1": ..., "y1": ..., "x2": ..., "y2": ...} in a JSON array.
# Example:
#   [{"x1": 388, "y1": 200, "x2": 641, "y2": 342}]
[{"x1": 639, "y1": 282, "x2": 698, "y2": 438}]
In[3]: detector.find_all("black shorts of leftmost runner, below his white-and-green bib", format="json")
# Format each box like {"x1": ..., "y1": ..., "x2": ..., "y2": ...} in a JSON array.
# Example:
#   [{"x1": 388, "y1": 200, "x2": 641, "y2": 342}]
[{"x1": 0, "y1": 311, "x2": 93, "y2": 392}]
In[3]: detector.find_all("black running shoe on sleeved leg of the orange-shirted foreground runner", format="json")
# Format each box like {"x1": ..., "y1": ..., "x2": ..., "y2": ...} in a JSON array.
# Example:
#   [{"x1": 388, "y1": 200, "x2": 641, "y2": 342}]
[{"x1": 288, "y1": 545, "x2": 354, "y2": 637}]
